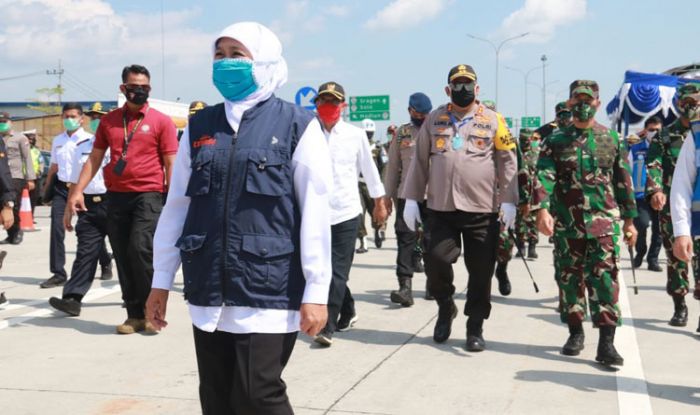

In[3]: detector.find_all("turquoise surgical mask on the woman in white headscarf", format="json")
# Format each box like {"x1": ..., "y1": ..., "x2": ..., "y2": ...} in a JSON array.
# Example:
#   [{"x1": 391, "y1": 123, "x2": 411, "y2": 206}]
[{"x1": 212, "y1": 58, "x2": 258, "y2": 101}]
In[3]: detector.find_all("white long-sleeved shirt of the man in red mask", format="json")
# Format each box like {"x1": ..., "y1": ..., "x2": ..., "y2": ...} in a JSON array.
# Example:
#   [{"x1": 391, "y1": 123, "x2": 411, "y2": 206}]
[{"x1": 323, "y1": 120, "x2": 384, "y2": 225}]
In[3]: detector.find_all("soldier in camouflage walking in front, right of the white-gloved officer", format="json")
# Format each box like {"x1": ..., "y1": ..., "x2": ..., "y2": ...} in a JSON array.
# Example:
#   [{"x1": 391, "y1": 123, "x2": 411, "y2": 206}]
[{"x1": 535, "y1": 81, "x2": 637, "y2": 365}]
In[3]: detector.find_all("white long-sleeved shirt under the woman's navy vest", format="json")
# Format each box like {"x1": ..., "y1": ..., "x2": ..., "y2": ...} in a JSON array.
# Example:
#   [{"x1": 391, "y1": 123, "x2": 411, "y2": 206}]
[{"x1": 152, "y1": 116, "x2": 332, "y2": 333}]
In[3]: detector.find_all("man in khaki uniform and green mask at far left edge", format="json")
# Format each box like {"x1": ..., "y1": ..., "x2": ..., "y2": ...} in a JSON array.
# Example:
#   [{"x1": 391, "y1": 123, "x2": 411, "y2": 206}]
[{"x1": 0, "y1": 112, "x2": 36, "y2": 245}]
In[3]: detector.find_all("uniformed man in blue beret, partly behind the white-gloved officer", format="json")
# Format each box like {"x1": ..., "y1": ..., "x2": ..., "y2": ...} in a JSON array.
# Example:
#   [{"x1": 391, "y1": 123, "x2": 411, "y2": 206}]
[{"x1": 384, "y1": 92, "x2": 433, "y2": 307}]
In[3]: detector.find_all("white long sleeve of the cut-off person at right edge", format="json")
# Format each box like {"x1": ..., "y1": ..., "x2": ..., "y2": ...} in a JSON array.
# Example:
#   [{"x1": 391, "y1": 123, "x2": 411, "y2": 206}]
[{"x1": 669, "y1": 132, "x2": 697, "y2": 236}]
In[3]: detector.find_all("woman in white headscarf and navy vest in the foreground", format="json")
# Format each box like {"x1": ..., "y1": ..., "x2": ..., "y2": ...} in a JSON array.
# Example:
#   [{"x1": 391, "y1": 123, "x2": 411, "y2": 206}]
[{"x1": 146, "y1": 22, "x2": 332, "y2": 414}]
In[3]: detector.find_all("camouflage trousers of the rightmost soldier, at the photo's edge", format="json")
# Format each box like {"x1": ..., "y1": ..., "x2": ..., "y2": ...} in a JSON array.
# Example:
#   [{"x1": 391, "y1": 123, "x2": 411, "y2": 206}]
[{"x1": 659, "y1": 210, "x2": 700, "y2": 297}]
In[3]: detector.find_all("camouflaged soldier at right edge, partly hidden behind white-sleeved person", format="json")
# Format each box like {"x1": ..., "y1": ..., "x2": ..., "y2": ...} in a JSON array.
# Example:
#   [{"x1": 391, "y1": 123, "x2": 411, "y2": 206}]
[{"x1": 646, "y1": 83, "x2": 700, "y2": 327}]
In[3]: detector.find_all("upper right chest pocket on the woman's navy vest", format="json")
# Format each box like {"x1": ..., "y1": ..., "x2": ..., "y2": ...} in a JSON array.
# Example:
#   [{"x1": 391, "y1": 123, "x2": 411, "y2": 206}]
[{"x1": 245, "y1": 150, "x2": 292, "y2": 196}]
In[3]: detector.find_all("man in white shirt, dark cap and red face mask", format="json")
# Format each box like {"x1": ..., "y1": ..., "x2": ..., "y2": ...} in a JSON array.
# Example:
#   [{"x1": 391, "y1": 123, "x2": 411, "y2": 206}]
[{"x1": 314, "y1": 82, "x2": 387, "y2": 347}]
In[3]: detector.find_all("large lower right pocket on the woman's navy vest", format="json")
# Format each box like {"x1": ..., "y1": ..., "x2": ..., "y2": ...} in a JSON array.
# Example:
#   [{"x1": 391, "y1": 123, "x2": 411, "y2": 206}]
[{"x1": 239, "y1": 235, "x2": 294, "y2": 295}]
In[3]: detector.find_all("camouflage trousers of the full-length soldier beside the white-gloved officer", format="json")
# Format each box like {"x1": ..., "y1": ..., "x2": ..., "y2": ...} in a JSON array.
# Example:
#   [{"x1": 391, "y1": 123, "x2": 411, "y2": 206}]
[{"x1": 554, "y1": 235, "x2": 622, "y2": 327}]
